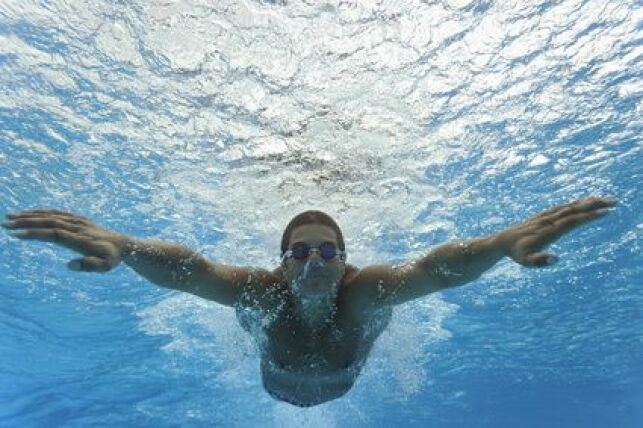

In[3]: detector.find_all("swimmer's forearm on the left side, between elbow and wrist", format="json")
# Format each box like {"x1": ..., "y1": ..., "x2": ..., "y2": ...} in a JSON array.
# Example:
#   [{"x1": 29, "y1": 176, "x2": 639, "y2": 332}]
[{"x1": 122, "y1": 237, "x2": 208, "y2": 290}]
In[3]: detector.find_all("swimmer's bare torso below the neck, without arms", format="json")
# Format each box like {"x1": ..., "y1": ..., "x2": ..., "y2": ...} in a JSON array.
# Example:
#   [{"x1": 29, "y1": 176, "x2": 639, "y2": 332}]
[{"x1": 237, "y1": 266, "x2": 392, "y2": 406}]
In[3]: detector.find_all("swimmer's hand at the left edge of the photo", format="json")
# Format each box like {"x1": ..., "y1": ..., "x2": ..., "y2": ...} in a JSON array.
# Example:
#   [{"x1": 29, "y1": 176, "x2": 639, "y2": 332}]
[{"x1": 2, "y1": 210, "x2": 129, "y2": 272}]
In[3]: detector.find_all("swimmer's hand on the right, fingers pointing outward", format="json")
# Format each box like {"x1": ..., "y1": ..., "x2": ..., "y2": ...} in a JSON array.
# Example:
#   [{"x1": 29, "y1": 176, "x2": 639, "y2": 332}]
[{"x1": 496, "y1": 197, "x2": 616, "y2": 267}]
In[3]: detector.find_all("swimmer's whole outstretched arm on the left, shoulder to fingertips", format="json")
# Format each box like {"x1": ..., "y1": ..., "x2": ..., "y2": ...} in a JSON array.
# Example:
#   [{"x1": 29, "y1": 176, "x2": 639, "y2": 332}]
[{"x1": 2, "y1": 210, "x2": 268, "y2": 306}]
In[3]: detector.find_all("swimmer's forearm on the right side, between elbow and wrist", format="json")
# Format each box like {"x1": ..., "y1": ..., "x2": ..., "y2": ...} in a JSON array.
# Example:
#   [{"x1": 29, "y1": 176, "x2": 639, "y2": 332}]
[{"x1": 420, "y1": 235, "x2": 506, "y2": 288}]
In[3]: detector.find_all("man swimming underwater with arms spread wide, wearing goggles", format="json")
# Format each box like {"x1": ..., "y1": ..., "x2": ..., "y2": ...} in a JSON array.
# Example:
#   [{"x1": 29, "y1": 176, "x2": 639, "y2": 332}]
[{"x1": 2, "y1": 197, "x2": 616, "y2": 407}]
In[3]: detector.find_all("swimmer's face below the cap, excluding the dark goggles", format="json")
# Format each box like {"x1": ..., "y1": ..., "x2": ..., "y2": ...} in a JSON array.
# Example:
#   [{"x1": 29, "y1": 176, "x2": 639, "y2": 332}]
[{"x1": 282, "y1": 224, "x2": 345, "y2": 297}]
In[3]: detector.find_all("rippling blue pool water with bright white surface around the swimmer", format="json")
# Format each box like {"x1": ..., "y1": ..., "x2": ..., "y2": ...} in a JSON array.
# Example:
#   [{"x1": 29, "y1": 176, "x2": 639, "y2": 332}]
[{"x1": 0, "y1": 0, "x2": 643, "y2": 428}]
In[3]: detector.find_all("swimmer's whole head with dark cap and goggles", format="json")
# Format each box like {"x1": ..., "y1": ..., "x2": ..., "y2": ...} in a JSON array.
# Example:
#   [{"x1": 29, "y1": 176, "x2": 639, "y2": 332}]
[{"x1": 281, "y1": 211, "x2": 346, "y2": 297}]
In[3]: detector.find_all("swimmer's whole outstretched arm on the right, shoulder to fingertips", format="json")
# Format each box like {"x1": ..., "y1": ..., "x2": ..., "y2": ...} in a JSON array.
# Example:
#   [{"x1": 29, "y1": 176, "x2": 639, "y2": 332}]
[{"x1": 353, "y1": 198, "x2": 615, "y2": 307}]
